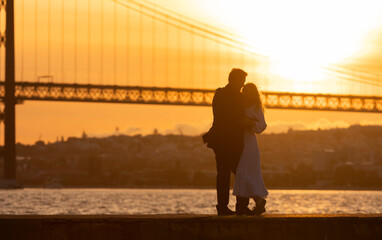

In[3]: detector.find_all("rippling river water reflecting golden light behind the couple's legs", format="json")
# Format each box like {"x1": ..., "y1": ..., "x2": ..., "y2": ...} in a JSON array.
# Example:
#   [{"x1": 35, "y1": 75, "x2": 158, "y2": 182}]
[{"x1": 0, "y1": 188, "x2": 382, "y2": 215}]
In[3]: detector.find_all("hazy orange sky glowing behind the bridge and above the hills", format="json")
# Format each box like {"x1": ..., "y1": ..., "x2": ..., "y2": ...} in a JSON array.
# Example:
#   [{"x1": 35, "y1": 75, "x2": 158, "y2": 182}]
[{"x1": 5, "y1": 0, "x2": 382, "y2": 143}]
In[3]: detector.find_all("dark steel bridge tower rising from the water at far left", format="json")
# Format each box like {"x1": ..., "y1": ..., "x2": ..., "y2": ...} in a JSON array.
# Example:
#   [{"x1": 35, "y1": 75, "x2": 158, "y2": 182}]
[{"x1": 0, "y1": 0, "x2": 19, "y2": 188}]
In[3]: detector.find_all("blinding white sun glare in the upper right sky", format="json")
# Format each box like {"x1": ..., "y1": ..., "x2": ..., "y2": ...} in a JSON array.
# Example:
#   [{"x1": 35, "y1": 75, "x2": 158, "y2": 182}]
[{"x1": 203, "y1": 0, "x2": 382, "y2": 88}]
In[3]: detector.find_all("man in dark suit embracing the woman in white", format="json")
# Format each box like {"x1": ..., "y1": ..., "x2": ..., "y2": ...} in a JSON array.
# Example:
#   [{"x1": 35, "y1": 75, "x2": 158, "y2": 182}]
[{"x1": 203, "y1": 68, "x2": 252, "y2": 215}]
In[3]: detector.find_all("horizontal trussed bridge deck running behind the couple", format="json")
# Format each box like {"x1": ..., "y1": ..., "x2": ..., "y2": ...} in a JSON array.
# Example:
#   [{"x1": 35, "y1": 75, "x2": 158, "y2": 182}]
[{"x1": 0, "y1": 82, "x2": 382, "y2": 113}]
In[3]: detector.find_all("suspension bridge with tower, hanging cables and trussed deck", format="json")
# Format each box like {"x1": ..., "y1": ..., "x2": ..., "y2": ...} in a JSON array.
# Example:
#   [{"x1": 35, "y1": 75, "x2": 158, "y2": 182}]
[{"x1": 0, "y1": 0, "x2": 382, "y2": 184}]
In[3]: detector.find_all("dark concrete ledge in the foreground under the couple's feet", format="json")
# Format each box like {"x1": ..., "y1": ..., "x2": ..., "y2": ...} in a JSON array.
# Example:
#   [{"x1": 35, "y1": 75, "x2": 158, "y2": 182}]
[{"x1": 0, "y1": 214, "x2": 382, "y2": 240}]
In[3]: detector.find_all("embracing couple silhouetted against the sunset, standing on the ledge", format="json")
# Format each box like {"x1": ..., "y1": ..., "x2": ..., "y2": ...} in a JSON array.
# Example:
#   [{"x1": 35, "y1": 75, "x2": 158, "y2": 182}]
[{"x1": 203, "y1": 68, "x2": 268, "y2": 215}]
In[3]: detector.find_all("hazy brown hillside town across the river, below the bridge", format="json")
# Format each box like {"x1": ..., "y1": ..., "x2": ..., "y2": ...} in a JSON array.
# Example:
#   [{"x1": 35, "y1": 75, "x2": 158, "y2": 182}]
[{"x1": 0, "y1": 125, "x2": 382, "y2": 189}]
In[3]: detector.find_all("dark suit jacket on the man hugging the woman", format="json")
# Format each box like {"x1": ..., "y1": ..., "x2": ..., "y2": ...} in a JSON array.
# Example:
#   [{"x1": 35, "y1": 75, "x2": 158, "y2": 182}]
[{"x1": 203, "y1": 84, "x2": 244, "y2": 170}]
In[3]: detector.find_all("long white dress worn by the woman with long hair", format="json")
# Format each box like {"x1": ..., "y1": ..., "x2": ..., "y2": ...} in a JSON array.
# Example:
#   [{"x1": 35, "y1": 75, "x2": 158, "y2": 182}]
[{"x1": 233, "y1": 105, "x2": 268, "y2": 198}]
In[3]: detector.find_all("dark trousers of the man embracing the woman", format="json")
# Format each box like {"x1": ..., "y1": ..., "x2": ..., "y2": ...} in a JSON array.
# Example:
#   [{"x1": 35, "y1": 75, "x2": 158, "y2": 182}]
[{"x1": 215, "y1": 150, "x2": 249, "y2": 208}]
